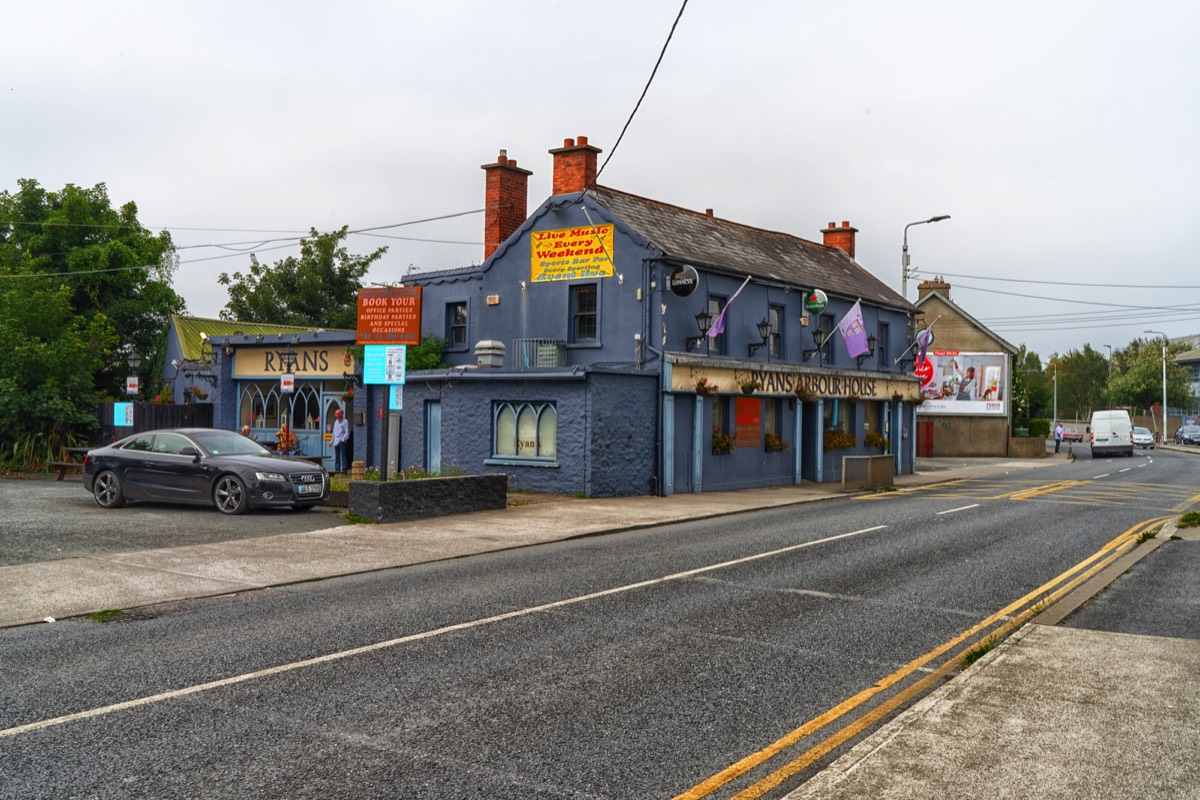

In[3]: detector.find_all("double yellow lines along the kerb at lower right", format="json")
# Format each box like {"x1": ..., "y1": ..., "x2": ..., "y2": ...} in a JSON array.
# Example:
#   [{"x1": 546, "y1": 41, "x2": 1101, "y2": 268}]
[{"x1": 674, "y1": 517, "x2": 1170, "y2": 800}]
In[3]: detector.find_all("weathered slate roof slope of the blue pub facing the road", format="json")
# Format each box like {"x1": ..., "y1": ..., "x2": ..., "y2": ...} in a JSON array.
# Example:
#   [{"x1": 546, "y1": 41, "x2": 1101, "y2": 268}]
[{"x1": 588, "y1": 186, "x2": 916, "y2": 311}]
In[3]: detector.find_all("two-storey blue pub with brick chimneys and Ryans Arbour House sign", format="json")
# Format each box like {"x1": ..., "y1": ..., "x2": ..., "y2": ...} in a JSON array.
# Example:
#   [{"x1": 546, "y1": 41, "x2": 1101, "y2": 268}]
[{"x1": 355, "y1": 137, "x2": 919, "y2": 497}]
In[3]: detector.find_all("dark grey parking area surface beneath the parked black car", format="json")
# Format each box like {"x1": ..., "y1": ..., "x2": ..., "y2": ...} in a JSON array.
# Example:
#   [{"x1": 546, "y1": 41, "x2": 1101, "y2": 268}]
[{"x1": 0, "y1": 475, "x2": 344, "y2": 566}]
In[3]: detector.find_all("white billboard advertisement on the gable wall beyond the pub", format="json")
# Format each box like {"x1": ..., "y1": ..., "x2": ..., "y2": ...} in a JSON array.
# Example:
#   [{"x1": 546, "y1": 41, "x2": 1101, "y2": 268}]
[{"x1": 916, "y1": 350, "x2": 1008, "y2": 416}]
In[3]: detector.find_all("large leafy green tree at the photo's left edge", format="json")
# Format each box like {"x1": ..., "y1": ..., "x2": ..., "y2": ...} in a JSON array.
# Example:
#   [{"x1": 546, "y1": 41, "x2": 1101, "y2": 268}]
[{"x1": 0, "y1": 180, "x2": 186, "y2": 467}]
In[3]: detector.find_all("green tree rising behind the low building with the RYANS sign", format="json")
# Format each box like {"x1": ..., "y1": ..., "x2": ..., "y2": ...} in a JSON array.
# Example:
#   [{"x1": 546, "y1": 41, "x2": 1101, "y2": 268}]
[{"x1": 217, "y1": 225, "x2": 388, "y2": 329}]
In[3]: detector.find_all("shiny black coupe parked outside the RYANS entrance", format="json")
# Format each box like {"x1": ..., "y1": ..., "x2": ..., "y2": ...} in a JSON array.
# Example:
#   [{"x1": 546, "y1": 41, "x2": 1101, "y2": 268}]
[{"x1": 83, "y1": 428, "x2": 329, "y2": 513}]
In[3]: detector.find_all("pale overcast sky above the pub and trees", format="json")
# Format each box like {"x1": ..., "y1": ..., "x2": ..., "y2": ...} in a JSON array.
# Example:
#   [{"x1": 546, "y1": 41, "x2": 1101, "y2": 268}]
[{"x1": 0, "y1": 0, "x2": 1200, "y2": 359}]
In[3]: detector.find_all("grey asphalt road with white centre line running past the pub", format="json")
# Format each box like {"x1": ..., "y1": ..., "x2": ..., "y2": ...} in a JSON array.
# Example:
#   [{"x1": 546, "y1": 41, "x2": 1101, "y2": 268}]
[{"x1": 0, "y1": 455, "x2": 1200, "y2": 800}]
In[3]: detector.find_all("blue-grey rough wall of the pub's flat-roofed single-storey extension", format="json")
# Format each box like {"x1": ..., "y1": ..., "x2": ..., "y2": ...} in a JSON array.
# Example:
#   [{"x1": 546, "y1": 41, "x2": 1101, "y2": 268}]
[{"x1": 401, "y1": 369, "x2": 659, "y2": 498}]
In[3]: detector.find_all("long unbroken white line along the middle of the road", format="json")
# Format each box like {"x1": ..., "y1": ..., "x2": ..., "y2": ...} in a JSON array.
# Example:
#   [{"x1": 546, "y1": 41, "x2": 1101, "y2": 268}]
[{"x1": 0, "y1": 525, "x2": 887, "y2": 739}]
